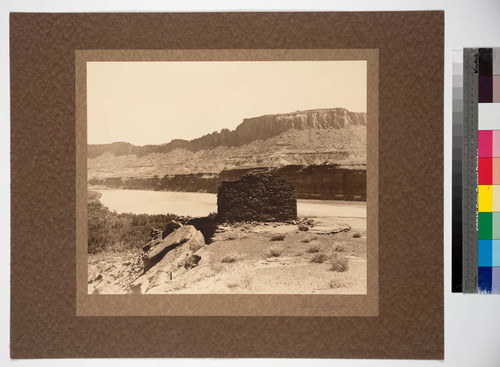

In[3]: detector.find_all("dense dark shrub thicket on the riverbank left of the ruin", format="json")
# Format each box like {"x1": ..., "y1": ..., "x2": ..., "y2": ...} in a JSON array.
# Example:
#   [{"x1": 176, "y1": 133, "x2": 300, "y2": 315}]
[{"x1": 87, "y1": 191, "x2": 176, "y2": 254}]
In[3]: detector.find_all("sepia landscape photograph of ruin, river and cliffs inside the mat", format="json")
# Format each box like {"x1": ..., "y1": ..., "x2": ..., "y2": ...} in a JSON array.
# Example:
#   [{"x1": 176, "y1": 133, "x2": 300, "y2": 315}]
[{"x1": 86, "y1": 60, "x2": 368, "y2": 295}]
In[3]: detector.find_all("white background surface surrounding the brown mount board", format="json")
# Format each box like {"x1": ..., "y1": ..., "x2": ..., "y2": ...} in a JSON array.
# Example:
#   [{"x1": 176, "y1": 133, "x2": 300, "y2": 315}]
[{"x1": 0, "y1": 0, "x2": 500, "y2": 367}]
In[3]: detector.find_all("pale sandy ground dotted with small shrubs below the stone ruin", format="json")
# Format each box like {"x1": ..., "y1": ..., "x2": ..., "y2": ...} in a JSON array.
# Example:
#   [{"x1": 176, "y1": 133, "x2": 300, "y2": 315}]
[{"x1": 89, "y1": 217, "x2": 367, "y2": 294}]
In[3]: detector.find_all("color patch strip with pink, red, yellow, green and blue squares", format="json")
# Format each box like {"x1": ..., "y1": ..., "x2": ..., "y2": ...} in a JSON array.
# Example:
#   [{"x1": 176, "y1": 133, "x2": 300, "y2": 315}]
[{"x1": 477, "y1": 48, "x2": 500, "y2": 293}]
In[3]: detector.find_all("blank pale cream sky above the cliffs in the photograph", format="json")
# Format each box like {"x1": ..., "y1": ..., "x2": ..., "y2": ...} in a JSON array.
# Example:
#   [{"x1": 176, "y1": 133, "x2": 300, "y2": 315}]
[{"x1": 87, "y1": 61, "x2": 367, "y2": 145}]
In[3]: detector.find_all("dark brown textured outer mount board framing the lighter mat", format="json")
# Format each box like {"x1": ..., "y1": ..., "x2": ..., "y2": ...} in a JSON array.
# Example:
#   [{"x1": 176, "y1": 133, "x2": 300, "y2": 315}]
[{"x1": 10, "y1": 12, "x2": 444, "y2": 359}]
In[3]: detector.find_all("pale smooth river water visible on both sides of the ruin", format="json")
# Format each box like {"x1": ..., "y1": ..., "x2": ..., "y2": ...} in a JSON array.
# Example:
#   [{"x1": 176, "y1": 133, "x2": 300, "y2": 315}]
[{"x1": 96, "y1": 190, "x2": 366, "y2": 229}]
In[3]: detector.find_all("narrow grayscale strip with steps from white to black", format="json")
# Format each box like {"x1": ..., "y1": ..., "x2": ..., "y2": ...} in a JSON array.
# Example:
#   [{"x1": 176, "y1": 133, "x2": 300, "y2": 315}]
[{"x1": 451, "y1": 51, "x2": 464, "y2": 292}]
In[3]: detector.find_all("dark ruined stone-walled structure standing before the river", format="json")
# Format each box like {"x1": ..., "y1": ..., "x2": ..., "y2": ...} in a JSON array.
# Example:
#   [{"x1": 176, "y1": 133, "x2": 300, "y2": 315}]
[{"x1": 217, "y1": 173, "x2": 297, "y2": 222}]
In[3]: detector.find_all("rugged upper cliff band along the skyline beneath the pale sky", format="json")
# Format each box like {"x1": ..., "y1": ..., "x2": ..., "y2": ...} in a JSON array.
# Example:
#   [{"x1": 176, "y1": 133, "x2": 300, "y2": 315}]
[{"x1": 87, "y1": 108, "x2": 366, "y2": 158}]
